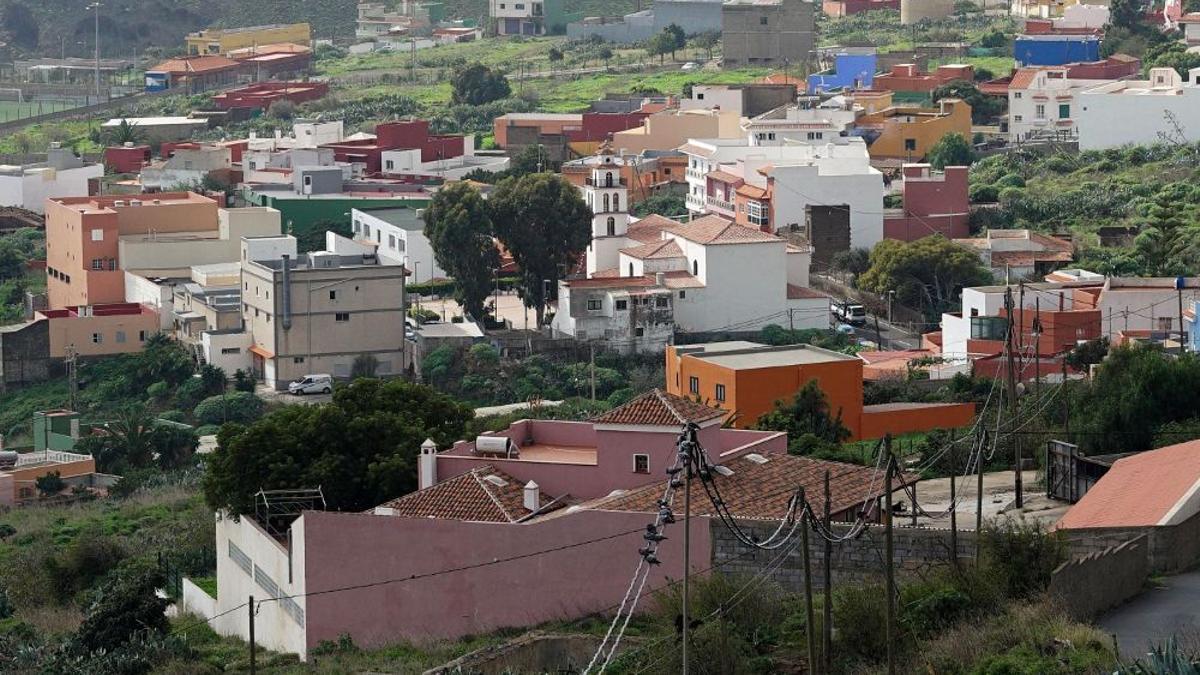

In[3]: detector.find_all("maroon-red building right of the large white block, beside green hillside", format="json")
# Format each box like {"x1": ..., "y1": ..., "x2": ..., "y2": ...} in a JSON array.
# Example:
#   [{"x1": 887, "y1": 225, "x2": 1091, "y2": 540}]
[{"x1": 883, "y1": 165, "x2": 971, "y2": 241}]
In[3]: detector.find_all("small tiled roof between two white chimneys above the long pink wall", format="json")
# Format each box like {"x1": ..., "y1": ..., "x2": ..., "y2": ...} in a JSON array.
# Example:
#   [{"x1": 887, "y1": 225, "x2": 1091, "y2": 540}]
[{"x1": 380, "y1": 465, "x2": 553, "y2": 522}]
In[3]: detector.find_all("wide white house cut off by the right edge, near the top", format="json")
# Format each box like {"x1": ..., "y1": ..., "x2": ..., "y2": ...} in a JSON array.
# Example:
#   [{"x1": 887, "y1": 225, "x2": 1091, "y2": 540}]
[{"x1": 1076, "y1": 68, "x2": 1200, "y2": 150}]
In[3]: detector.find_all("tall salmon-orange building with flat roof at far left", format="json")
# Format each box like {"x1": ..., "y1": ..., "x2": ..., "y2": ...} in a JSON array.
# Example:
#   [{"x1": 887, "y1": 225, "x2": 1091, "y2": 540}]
[{"x1": 46, "y1": 192, "x2": 218, "y2": 307}]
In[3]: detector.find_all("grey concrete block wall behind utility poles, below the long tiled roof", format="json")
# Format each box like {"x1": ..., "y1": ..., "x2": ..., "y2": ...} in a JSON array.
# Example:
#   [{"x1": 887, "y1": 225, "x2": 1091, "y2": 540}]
[{"x1": 710, "y1": 520, "x2": 974, "y2": 592}]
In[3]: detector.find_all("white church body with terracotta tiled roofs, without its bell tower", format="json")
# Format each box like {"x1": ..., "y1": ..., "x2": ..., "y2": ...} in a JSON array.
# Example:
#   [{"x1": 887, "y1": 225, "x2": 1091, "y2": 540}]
[{"x1": 552, "y1": 215, "x2": 829, "y2": 352}]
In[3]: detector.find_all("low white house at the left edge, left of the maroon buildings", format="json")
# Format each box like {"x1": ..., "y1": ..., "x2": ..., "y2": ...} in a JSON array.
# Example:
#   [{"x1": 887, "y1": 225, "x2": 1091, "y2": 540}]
[{"x1": 0, "y1": 147, "x2": 104, "y2": 214}]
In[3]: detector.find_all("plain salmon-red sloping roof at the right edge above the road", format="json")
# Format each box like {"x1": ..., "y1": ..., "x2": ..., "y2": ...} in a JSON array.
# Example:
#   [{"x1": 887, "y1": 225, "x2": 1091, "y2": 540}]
[{"x1": 1055, "y1": 441, "x2": 1200, "y2": 530}]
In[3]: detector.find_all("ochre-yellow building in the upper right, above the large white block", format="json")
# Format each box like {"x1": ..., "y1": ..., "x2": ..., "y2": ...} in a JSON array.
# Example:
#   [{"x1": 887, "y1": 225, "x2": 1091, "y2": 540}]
[{"x1": 856, "y1": 98, "x2": 971, "y2": 162}]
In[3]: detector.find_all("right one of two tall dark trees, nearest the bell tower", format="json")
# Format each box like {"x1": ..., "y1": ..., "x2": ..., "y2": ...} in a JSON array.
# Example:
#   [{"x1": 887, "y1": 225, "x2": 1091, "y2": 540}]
[{"x1": 487, "y1": 173, "x2": 592, "y2": 325}]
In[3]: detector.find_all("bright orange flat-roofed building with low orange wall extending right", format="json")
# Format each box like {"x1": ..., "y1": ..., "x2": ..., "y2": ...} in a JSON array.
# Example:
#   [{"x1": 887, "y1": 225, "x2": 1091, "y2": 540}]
[{"x1": 666, "y1": 341, "x2": 974, "y2": 441}]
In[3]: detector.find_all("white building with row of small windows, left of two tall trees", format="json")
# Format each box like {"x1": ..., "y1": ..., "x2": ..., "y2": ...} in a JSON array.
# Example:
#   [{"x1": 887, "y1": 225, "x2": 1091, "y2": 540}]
[{"x1": 350, "y1": 207, "x2": 446, "y2": 283}]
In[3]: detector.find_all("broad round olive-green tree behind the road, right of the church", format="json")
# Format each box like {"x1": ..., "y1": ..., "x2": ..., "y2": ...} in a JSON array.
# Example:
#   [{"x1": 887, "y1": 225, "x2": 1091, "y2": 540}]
[{"x1": 858, "y1": 234, "x2": 991, "y2": 318}]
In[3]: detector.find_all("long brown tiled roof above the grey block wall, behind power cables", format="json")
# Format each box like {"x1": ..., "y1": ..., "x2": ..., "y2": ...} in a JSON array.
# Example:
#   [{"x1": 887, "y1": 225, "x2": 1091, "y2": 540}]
[{"x1": 590, "y1": 454, "x2": 917, "y2": 519}]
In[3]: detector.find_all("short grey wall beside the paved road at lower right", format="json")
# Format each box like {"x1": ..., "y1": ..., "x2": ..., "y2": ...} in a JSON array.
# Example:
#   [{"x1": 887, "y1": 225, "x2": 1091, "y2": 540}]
[{"x1": 1050, "y1": 534, "x2": 1150, "y2": 621}]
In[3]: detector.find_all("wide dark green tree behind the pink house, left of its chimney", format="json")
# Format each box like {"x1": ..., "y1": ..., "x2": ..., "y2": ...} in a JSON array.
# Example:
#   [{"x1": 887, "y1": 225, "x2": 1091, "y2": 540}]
[{"x1": 204, "y1": 378, "x2": 473, "y2": 515}]
